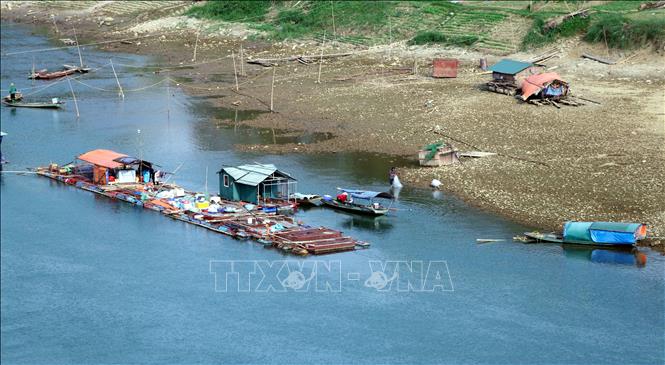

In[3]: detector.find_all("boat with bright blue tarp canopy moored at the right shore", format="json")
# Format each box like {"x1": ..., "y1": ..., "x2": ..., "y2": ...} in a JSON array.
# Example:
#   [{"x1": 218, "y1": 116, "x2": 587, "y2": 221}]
[{"x1": 524, "y1": 221, "x2": 647, "y2": 246}]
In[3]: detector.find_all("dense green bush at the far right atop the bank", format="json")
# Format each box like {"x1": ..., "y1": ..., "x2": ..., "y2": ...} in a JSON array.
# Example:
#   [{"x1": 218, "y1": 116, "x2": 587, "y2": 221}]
[{"x1": 584, "y1": 14, "x2": 665, "y2": 49}]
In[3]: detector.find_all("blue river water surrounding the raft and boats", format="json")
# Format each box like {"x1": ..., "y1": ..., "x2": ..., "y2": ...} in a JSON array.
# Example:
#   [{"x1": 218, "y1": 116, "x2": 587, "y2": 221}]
[{"x1": 0, "y1": 24, "x2": 665, "y2": 364}]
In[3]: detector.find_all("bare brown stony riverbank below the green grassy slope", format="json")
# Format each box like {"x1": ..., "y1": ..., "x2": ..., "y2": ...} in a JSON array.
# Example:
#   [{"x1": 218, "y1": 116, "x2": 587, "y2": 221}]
[{"x1": 2, "y1": 2, "x2": 665, "y2": 250}]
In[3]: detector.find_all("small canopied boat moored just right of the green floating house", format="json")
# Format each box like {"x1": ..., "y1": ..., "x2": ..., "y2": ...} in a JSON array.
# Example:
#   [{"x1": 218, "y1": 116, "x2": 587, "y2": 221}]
[{"x1": 321, "y1": 189, "x2": 394, "y2": 216}]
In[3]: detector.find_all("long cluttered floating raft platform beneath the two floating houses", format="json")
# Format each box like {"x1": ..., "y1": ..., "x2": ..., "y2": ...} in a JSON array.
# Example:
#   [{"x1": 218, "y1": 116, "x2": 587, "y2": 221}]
[{"x1": 35, "y1": 167, "x2": 369, "y2": 255}]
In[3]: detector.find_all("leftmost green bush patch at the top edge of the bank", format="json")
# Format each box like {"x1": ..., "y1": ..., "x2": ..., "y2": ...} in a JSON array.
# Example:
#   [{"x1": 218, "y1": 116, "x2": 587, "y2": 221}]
[{"x1": 187, "y1": 0, "x2": 271, "y2": 22}]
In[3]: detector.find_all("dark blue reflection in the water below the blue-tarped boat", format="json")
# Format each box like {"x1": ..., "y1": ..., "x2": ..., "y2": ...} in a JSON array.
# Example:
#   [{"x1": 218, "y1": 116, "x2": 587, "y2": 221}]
[{"x1": 561, "y1": 245, "x2": 647, "y2": 267}]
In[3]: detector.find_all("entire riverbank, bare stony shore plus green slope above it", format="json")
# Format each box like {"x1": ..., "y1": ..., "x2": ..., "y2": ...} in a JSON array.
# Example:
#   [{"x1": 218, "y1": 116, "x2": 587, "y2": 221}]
[{"x1": 2, "y1": 1, "x2": 665, "y2": 251}]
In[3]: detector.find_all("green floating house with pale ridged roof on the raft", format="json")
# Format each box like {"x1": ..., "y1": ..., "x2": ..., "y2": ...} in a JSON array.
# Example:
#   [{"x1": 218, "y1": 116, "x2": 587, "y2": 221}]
[{"x1": 217, "y1": 164, "x2": 297, "y2": 204}]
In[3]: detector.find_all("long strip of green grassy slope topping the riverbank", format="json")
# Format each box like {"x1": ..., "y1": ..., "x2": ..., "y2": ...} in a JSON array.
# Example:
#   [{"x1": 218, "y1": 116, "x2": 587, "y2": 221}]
[{"x1": 187, "y1": 0, "x2": 665, "y2": 50}]
